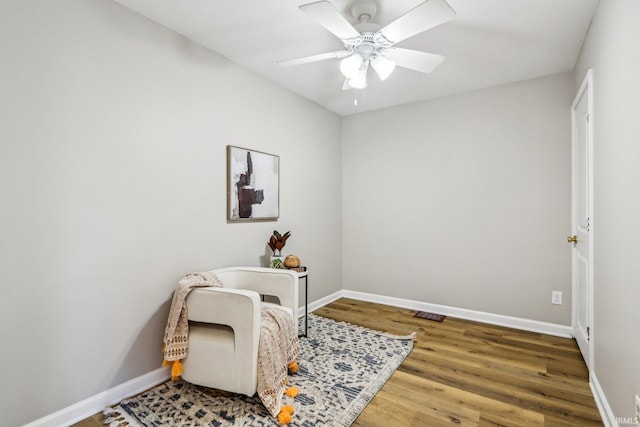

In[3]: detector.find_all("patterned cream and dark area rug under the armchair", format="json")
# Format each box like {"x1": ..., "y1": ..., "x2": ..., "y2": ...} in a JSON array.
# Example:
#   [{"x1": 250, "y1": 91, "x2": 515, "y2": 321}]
[{"x1": 105, "y1": 314, "x2": 413, "y2": 427}]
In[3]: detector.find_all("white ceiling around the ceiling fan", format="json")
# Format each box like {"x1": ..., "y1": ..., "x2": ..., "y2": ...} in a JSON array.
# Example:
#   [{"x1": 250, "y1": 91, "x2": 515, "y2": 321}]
[{"x1": 114, "y1": 0, "x2": 598, "y2": 115}]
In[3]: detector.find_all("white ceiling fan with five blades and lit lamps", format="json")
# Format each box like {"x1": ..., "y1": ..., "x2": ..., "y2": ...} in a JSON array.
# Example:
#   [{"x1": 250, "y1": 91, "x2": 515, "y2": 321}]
[{"x1": 279, "y1": 0, "x2": 456, "y2": 90}]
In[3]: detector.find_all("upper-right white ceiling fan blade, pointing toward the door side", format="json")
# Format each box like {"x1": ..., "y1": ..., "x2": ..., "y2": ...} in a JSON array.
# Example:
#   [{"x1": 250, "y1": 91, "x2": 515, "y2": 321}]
[{"x1": 376, "y1": 0, "x2": 456, "y2": 44}]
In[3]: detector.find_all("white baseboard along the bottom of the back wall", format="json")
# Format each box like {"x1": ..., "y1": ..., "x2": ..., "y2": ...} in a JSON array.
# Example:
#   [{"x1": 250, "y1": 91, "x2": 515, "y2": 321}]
[{"x1": 341, "y1": 290, "x2": 572, "y2": 338}]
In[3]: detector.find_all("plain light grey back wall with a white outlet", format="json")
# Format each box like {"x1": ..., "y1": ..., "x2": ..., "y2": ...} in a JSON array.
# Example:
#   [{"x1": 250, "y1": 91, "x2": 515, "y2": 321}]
[{"x1": 343, "y1": 73, "x2": 574, "y2": 325}]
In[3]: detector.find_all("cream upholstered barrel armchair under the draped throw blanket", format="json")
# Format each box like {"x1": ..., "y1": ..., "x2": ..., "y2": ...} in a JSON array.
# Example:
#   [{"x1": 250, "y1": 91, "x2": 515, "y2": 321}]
[{"x1": 182, "y1": 267, "x2": 298, "y2": 396}]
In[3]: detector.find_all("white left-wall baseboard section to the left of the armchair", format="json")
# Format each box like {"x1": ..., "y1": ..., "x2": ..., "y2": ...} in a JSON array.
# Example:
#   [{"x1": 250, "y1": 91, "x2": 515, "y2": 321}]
[{"x1": 25, "y1": 368, "x2": 170, "y2": 427}]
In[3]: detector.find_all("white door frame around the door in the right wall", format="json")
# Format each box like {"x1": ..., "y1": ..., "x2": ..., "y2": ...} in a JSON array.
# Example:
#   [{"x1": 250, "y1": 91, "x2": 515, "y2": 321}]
[{"x1": 571, "y1": 69, "x2": 596, "y2": 371}]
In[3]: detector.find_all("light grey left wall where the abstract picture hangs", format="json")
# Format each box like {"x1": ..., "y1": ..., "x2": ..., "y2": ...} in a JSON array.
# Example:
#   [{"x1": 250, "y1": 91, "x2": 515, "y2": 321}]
[{"x1": 0, "y1": 0, "x2": 342, "y2": 426}]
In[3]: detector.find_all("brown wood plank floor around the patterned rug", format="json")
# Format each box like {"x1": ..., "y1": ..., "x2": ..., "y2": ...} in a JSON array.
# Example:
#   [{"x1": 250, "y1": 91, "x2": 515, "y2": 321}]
[{"x1": 75, "y1": 298, "x2": 603, "y2": 427}]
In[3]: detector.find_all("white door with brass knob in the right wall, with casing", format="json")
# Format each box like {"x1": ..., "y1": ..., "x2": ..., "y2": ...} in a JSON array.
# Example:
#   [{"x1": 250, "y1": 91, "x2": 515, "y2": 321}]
[{"x1": 567, "y1": 70, "x2": 593, "y2": 369}]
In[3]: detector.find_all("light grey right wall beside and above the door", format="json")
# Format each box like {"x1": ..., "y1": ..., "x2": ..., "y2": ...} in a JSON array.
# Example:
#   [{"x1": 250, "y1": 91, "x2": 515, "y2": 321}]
[{"x1": 575, "y1": 0, "x2": 640, "y2": 418}]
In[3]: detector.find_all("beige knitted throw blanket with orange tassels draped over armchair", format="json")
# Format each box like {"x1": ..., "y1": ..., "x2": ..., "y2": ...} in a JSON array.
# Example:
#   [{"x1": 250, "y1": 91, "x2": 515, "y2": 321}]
[{"x1": 164, "y1": 272, "x2": 300, "y2": 417}]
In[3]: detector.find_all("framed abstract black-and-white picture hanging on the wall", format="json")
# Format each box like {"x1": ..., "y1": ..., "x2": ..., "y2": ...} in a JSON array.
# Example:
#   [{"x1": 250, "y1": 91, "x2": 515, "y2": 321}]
[{"x1": 227, "y1": 145, "x2": 280, "y2": 221}]
